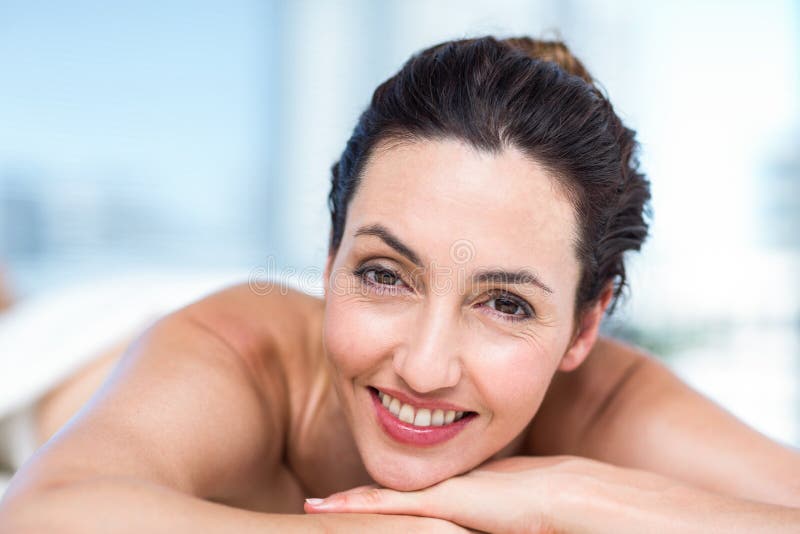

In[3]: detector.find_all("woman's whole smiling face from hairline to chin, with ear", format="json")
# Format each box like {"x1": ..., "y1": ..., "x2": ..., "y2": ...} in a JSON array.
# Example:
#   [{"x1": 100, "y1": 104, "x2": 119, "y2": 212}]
[{"x1": 323, "y1": 140, "x2": 596, "y2": 490}]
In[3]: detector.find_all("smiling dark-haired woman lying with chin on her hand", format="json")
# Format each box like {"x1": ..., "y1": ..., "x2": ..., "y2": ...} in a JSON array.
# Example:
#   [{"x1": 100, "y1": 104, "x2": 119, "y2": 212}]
[{"x1": 0, "y1": 37, "x2": 800, "y2": 532}]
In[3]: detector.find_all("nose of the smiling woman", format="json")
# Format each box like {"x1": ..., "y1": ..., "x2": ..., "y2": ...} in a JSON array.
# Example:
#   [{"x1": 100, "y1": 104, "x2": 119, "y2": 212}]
[{"x1": 392, "y1": 306, "x2": 462, "y2": 393}]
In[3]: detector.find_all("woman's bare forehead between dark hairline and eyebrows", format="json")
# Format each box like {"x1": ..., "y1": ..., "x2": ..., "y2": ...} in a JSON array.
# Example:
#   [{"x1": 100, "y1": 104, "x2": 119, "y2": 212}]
[{"x1": 344, "y1": 139, "x2": 576, "y2": 288}]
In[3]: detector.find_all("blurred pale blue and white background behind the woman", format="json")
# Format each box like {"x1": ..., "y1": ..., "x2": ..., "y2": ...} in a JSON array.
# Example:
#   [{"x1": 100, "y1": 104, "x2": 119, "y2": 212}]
[{"x1": 0, "y1": 0, "x2": 800, "y2": 446}]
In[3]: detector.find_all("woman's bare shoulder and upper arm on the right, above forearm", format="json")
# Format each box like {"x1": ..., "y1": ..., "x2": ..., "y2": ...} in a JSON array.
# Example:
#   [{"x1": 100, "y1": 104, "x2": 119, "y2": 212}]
[{"x1": 531, "y1": 339, "x2": 800, "y2": 507}]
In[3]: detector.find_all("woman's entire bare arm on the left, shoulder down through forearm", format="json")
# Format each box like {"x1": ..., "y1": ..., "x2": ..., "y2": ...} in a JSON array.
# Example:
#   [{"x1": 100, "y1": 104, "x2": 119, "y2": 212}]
[{"x1": 0, "y1": 288, "x2": 468, "y2": 532}]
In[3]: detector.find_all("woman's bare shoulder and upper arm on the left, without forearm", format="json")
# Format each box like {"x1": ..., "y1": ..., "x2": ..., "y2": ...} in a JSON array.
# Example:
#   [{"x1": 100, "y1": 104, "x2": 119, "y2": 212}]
[{"x1": 3, "y1": 284, "x2": 319, "y2": 511}]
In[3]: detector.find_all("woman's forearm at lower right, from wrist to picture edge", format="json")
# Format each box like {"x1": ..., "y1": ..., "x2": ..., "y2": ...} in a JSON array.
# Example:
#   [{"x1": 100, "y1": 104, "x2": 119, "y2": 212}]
[{"x1": 554, "y1": 481, "x2": 800, "y2": 534}]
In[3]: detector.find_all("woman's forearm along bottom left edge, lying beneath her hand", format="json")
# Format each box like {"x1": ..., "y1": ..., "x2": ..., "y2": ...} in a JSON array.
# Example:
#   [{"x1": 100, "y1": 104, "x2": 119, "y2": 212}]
[{"x1": 0, "y1": 478, "x2": 460, "y2": 534}]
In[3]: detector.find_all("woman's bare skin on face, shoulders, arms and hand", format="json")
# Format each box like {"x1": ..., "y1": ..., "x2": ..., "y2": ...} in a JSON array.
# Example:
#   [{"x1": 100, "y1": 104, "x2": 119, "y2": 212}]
[{"x1": 0, "y1": 143, "x2": 800, "y2": 532}]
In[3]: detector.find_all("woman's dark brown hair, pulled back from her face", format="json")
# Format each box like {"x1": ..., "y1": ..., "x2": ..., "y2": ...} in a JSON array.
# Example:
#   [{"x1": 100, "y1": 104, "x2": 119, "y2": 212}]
[{"x1": 328, "y1": 36, "x2": 650, "y2": 316}]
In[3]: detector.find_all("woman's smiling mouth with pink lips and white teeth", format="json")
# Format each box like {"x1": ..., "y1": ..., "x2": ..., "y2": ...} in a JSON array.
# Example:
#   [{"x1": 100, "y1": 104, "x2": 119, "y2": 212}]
[{"x1": 367, "y1": 386, "x2": 478, "y2": 446}]
